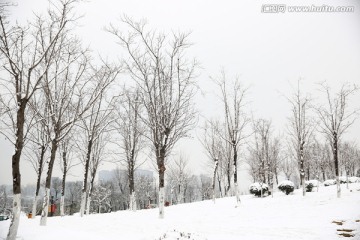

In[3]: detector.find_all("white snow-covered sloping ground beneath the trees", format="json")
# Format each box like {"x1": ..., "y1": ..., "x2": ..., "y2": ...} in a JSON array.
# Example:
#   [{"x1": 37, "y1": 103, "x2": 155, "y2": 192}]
[{"x1": 0, "y1": 183, "x2": 360, "y2": 240}]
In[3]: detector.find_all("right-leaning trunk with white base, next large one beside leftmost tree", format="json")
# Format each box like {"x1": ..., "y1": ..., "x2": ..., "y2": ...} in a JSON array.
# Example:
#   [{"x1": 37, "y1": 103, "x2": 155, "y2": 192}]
[{"x1": 40, "y1": 138, "x2": 58, "y2": 226}]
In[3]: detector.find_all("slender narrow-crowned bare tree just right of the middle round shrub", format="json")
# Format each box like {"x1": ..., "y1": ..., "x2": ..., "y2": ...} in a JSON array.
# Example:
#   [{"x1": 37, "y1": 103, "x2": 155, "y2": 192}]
[{"x1": 288, "y1": 81, "x2": 314, "y2": 196}]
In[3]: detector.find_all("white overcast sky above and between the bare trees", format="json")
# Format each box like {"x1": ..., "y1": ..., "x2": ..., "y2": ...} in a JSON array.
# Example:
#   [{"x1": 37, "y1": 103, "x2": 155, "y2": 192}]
[{"x1": 0, "y1": 0, "x2": 360, "y2": 189}]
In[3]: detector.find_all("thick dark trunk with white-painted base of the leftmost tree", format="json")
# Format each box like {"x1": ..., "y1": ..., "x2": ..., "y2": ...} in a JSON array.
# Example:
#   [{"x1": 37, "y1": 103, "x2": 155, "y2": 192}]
[{"x1": 6, "y1": 100, "x2": 27, "y2": 240}]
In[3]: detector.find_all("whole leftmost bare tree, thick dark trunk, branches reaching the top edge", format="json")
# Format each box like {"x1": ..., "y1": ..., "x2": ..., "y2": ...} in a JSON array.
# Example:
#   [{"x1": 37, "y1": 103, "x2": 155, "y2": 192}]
[{"x1": 0, "y1": 0, "x2": 76, "y2": 240}]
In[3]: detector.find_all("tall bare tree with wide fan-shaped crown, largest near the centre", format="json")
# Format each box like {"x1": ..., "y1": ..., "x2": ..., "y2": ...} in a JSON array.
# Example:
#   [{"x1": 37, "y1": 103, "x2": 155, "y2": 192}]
[{"x1": 108, "y1": 17, "x2": 196, "y2": 218}]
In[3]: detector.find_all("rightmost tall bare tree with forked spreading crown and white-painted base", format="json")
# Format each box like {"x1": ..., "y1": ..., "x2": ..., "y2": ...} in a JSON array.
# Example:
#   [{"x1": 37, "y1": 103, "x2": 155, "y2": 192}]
[{"x1": 316, "y1": 83, "x2": 358, "y2": 198}]
